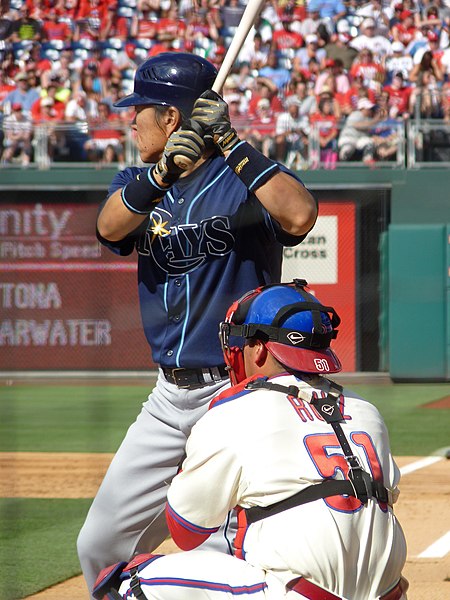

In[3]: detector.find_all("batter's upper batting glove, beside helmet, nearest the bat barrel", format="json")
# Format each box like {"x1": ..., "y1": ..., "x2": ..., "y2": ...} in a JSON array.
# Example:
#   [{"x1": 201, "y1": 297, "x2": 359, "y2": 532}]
[{"x1": 191, "y1": 90, "x2": 240, "y2": 154}]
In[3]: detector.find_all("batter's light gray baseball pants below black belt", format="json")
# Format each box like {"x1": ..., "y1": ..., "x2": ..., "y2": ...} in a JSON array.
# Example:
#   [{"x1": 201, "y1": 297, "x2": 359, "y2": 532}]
[{"x1": 77, "y1": 370, "x2": 230, "y2": 590}]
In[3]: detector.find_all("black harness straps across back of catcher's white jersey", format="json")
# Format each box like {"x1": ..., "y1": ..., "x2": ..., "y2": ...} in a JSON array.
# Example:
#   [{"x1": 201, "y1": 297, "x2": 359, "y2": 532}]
[{"x1": 245, "y1": 379, "x2": 389, "y2": 525}]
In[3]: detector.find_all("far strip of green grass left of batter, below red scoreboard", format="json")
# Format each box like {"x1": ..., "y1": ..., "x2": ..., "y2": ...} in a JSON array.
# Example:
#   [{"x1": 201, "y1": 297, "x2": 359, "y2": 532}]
[{"x1": 0, "y1": 380, "x2": 154, "y2": 452}]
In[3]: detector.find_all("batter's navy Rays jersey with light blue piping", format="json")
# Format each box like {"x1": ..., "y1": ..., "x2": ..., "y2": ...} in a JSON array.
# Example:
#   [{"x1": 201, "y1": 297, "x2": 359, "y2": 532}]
[{"x1": 101, "y1": 156, "x2": 314, "y2": 368}]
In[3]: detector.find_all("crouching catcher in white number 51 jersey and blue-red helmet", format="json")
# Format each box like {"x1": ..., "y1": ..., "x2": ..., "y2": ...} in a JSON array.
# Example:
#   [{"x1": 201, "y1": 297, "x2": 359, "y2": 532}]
[{"x1": 94, "y1": 281, "x2": 407, "y2": 600}]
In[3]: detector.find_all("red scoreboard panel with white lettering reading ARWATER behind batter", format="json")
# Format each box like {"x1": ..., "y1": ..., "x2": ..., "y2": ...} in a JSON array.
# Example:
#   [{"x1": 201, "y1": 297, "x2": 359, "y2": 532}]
[{"x1": 0, "y1": 203, "x2": 152, "y2": 370}]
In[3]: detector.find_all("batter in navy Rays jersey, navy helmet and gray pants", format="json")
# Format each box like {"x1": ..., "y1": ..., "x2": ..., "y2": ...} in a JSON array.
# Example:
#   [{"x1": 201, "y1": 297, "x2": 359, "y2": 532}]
[{"x1": 78, "y1": 53, "x2": 317, "y2": 589}]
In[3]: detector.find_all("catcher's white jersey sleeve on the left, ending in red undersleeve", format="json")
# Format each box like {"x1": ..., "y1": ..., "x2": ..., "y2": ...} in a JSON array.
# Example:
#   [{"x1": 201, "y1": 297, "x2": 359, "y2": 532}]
[{"x1": 166, "y1": 407, "x2": 242, "y2": 550}]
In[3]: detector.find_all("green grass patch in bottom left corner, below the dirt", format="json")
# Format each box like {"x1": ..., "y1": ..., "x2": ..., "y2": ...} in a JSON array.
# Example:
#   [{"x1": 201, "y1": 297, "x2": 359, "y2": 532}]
[{"x1": 0, "y1": 498, "x2": 91, "y2": 600}]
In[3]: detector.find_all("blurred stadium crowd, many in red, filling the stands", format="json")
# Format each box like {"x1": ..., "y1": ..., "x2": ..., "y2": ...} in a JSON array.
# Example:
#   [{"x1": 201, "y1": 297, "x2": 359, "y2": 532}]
[{"x1": 0, "y1": 0, "x2": 450, "y2": 168}]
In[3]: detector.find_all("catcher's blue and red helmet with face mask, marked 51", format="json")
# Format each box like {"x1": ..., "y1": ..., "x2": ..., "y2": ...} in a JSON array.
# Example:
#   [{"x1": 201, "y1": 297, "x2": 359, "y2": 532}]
[{"x1": 219, "y1": 279, "x2": 341, "y2": 385}]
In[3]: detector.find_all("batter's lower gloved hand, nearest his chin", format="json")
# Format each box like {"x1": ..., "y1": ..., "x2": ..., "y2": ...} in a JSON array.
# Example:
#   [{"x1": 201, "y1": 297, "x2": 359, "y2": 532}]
[{"x1": 154, "y1": 129, "x2": 205, "y2": 185}]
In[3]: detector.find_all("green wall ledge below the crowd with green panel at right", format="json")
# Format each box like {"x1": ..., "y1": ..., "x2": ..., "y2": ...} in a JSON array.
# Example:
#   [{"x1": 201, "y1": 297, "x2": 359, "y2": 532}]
[{"x1": 0, "y1": 167, "x2": 450, "y2": 380}]
